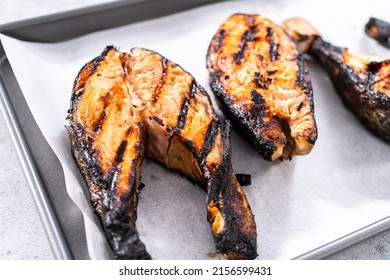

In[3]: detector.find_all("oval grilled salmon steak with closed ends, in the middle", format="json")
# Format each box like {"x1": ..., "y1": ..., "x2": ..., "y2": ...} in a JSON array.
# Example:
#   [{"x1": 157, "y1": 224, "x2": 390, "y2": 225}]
[{"x1": 207, "y1": 14, "x2": 317, "y2": 161}]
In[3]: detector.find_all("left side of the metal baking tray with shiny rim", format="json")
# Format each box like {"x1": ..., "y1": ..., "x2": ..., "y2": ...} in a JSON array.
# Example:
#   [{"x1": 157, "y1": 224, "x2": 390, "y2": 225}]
[{"x1": 0, "y1": 37, "x2": 89, "y2": 260}]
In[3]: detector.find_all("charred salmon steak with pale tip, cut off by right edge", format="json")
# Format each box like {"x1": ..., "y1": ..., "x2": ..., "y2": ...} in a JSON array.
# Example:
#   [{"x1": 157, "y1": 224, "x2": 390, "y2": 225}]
[{"x1": 283, "y1": 18, "x2": 390, "y2": 142}]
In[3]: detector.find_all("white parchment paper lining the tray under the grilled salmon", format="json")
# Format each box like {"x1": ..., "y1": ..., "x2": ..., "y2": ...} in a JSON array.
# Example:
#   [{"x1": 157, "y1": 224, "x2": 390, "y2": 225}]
[{"x1": 0, "y1": 0, "x2": 390, "y2": 259}]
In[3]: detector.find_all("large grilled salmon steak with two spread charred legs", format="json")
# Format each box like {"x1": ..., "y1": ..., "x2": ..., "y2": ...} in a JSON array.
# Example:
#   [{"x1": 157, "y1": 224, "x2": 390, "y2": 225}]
[{"x1": 67, "y1": 46, "x2": 257, "y2": 259}]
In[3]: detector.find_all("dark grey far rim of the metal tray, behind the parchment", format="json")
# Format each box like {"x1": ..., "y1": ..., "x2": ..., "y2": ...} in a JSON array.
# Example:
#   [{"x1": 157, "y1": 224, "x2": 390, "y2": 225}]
[{"x1": 0, "y1": 0, "x2": 221, "y2": 42}]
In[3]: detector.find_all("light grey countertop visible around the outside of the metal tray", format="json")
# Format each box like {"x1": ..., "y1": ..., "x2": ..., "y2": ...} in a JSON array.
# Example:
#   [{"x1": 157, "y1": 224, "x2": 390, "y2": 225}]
[{"x1": 0, "y1": 0, "x2": 390, "y2": 260}]
